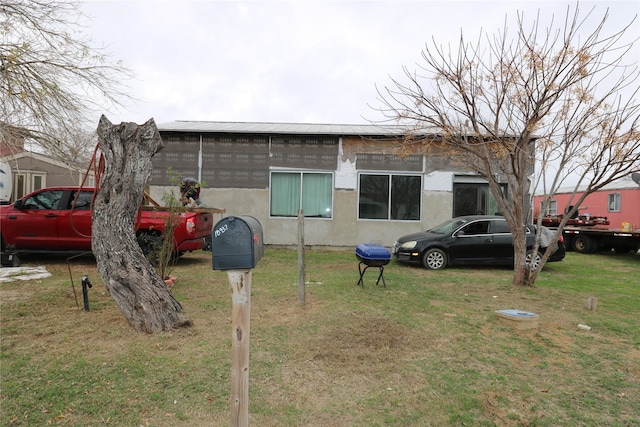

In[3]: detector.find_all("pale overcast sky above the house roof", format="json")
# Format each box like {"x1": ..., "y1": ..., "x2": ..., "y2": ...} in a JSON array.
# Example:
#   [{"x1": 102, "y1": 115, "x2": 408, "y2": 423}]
[{"x1": 82, "y1": 0, "x2": 640, "y2": 124}]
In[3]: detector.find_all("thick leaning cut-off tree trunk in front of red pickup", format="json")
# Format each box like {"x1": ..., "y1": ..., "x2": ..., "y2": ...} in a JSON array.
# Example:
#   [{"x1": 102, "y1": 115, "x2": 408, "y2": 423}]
[{"x1": 91, "y1": 116, "x2": 192, "y2": 333}]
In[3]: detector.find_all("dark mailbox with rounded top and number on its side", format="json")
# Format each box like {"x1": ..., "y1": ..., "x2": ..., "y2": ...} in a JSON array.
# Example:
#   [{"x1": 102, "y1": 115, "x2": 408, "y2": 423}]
[{"x1": 211, "y1": 216, "x2": 264, "y2": 270}]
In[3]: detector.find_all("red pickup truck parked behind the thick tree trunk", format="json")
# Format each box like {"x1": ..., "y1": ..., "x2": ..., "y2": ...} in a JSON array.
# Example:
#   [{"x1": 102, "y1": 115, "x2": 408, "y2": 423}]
[{"x1": 0, "y1": 187, "x2": 213, "y2": 261}]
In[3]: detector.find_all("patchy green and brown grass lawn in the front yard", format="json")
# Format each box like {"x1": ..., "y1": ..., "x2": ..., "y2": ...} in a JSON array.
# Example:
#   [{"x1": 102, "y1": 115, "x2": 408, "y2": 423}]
[{"x1": 0, "y1": 249, "x2": 640, "y2": 427}]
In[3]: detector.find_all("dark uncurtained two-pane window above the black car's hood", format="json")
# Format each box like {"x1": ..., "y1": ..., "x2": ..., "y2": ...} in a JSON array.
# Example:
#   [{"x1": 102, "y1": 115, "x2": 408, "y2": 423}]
[{"x1": 358, "y1": 174, "x2": 422, "y2": 221}]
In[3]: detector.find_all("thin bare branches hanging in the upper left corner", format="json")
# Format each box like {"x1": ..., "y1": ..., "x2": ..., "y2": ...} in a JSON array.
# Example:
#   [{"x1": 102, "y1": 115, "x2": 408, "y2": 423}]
[{"x1": 0, "y1": 0, "x2": 130, "y2": 153}]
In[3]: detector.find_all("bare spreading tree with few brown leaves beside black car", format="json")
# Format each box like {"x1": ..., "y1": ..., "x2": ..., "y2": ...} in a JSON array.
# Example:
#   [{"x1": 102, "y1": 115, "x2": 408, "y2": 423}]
[{"x1": 378, "y1": 4, "x2": 640, "y2": 285}]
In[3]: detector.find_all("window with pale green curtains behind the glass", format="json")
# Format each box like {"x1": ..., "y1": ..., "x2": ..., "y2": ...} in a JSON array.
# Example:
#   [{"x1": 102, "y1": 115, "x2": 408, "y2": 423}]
[{"x1": 271, "y1": 172, "x2": 333, "y2": 218}]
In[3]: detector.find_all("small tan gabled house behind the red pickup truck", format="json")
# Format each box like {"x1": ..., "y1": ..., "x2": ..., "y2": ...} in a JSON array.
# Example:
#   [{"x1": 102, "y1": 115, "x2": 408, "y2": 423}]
[{"x1": 0, "y1": 150, "x2": 95, "y2": 201}]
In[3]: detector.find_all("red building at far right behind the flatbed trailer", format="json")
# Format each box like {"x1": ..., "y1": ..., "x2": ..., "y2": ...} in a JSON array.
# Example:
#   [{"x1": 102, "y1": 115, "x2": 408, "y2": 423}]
[{"x1": 534, "y1": 174, "x2": 640, "y2": 228}]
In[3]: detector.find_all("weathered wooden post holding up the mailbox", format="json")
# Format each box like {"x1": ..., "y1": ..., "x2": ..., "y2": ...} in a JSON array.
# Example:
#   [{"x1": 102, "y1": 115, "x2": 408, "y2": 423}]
[{"x1": 227, "y1": 270, "x2": 252, "y2": 427}]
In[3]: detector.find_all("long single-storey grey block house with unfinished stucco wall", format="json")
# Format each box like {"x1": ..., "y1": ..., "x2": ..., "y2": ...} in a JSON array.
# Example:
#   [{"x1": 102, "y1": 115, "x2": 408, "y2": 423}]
[{"x1": 149, "y1": 121, "x2": 507, "y2": 247}]
